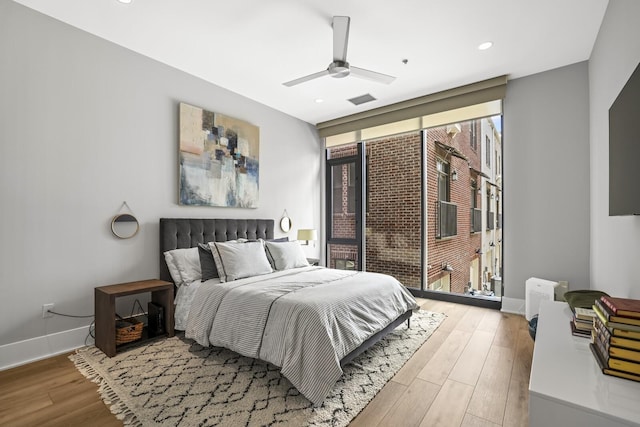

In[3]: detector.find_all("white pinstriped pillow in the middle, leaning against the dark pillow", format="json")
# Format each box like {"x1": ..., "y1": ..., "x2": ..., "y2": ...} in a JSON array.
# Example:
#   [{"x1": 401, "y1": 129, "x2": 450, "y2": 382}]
[{"x1": 209, "y1": 242, "x2": 273, "y2": 282}]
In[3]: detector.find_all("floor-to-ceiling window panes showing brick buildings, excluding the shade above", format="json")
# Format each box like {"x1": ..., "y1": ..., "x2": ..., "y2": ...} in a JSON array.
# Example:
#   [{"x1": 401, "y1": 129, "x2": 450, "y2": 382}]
[{"x1": 327, "y1": 117, "x2": 502, "y2": 306}]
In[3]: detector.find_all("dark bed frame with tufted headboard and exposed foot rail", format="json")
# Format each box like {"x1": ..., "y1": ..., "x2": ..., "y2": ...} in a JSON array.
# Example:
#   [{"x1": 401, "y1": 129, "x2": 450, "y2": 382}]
[{"x1": 160, "y1": 218, "x2": 413, "y2": 366}]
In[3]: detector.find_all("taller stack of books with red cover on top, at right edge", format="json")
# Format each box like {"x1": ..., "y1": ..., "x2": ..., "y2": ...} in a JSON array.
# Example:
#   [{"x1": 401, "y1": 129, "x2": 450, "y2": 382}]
[{"x1": 590, "y1": 296, "x2": 640, "y2": 381}]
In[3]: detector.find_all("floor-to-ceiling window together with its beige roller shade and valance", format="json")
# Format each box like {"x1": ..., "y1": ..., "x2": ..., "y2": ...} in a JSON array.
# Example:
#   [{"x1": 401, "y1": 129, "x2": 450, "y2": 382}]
[{"x1": 316, "y1": 76, "x2": 506, "y2": 307}]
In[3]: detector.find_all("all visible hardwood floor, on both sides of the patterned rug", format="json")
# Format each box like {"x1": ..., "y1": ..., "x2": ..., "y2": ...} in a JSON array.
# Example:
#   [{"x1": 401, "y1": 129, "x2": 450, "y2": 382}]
[{"x1": 0, "y1": 300, "x2": 533, "y2": 427}]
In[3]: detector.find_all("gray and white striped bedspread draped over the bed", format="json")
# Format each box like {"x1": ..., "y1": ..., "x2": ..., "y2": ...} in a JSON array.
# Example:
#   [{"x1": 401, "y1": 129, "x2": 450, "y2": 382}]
[{"x1": 185, "y1": 267, "x2": 418, "y2": 404}]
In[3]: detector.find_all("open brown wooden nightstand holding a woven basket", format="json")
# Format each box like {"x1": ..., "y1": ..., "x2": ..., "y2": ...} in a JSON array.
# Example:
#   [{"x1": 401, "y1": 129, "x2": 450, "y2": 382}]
[{"x1": 95, "y1": 279, "x2": 175, "y2": 357}]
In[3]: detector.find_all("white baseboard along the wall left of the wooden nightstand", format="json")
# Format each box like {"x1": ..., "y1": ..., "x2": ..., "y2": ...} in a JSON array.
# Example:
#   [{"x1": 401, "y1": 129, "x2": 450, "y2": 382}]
[{"x1": 0, "y1": 326, "x2": 93, "y2": 371}]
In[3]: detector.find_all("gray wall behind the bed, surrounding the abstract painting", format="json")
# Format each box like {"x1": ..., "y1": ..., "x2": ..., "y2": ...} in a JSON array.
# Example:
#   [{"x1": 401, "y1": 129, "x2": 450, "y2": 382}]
[{"x1": 0, "y1": 0, "x2": 323, "y2": 345}]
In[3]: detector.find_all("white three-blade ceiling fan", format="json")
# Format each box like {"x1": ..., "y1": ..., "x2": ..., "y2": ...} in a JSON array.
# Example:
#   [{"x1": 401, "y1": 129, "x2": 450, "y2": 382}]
[{"x1": 283, "y1": 16, "x2": 395, "y2": 87}]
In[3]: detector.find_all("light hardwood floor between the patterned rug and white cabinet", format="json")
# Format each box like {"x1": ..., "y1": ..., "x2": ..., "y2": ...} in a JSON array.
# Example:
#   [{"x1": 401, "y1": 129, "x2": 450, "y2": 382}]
[{"x1": 351, "y1": 300, "x2": 533, "y2": 427}]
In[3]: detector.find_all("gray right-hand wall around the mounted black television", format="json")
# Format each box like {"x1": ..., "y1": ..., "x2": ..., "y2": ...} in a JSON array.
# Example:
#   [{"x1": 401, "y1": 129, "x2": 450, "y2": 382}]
[{"x1": 589, "y1": 0, "x2": 640, "y2": 298}]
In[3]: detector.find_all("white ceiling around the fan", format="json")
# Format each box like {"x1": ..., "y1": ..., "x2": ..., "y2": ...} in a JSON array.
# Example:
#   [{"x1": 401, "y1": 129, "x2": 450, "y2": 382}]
[{"x1": 14, "y1": 0, "x2": 608, "y2": 124}]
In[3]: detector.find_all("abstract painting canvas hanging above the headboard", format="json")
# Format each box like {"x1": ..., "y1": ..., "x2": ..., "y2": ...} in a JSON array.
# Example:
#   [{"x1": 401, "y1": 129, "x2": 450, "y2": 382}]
[{"x1": 179, "y1": 103, "x2": 260, "y2": 208}]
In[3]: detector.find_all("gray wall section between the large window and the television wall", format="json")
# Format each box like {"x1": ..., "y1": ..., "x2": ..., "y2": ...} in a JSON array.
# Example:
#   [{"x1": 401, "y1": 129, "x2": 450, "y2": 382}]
[{"x1": 503, "y1": 62, "x2": 589, "y2": 299}]
